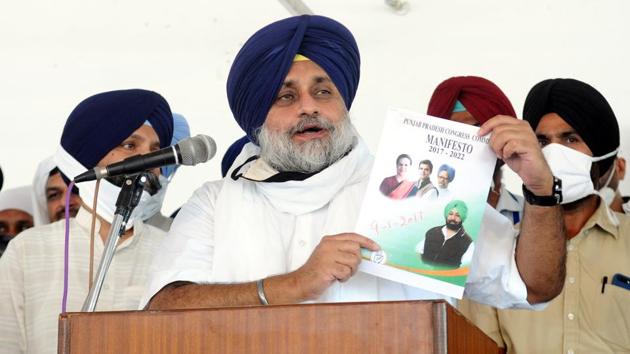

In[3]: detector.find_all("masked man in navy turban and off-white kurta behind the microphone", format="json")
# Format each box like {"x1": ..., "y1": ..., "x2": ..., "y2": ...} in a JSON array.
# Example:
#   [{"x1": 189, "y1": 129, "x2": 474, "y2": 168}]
[{"x1": 0, "y1": 89, "x2": 173, "y2": 353}]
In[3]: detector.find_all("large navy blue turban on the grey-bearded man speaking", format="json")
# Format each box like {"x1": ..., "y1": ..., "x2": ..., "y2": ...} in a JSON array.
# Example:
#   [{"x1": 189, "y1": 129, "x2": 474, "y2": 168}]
[{"x1": 227, "y1": 15, "x2": 361, "y2": 142}]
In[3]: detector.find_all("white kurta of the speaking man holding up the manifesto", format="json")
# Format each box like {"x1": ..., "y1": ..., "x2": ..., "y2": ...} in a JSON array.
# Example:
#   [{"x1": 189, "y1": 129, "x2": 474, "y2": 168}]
[{"x1": 141, "y1": 143, "x2": 544, "y2": 308}]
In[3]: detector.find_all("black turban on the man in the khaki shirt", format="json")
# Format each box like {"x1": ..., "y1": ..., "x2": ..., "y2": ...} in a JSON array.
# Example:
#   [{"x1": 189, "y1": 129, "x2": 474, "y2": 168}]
[{"x1": 523, "y1": 79, "x2": 620, "y2": 171}]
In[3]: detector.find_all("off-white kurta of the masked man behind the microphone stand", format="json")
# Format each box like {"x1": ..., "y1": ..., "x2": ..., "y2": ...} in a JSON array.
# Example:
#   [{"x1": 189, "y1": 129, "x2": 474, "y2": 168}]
[{"x1": 0, "y1": 209, "x2": 166, "y2": 354}]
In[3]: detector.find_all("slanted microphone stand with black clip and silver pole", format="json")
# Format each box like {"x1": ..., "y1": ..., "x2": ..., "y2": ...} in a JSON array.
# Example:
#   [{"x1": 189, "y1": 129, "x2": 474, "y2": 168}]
[{"x1": 81, "y1": 172, "x2": 148, "y2": 312}]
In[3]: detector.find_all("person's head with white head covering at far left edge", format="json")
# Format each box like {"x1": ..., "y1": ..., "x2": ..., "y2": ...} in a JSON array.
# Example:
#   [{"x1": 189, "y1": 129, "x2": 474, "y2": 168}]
[{"x1": 0, "y1": 186, "x2": 33, "y2": 256}]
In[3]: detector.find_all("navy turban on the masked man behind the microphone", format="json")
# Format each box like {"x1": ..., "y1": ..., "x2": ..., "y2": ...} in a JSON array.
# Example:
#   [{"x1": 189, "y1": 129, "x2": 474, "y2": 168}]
[{"x1": 61, "y1": 89, "x2": 173, "y2": 168}]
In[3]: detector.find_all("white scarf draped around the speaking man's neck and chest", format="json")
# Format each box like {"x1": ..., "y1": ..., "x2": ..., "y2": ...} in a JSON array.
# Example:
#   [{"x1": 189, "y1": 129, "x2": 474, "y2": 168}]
[{"x1": 211, "y1": 141, "x2": 373, "y2": 282}]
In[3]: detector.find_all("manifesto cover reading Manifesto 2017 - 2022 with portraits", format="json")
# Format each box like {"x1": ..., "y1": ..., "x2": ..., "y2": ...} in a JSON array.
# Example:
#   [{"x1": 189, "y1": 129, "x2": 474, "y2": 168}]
[{"x1": 356, "y1": 109, "x2": 497, "y2": 299}]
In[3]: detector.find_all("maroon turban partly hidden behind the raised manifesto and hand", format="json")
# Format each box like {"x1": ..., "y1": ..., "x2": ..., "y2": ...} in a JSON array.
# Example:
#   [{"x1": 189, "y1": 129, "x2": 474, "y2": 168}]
[{"x1": 427, "y1": 76, "x2": 516, "y2": 124}]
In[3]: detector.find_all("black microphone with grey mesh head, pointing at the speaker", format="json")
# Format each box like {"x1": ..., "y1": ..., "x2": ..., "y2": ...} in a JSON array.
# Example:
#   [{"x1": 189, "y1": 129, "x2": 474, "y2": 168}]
[{"x1": 74, "y1": 134, "x2": 217, "y2": 183}]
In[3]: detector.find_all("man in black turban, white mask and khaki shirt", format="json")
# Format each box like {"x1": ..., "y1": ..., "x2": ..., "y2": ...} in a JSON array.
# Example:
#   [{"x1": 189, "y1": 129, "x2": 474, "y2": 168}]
[{"x1": 460, "y1": 79, "x2": 630, "y2": 353}]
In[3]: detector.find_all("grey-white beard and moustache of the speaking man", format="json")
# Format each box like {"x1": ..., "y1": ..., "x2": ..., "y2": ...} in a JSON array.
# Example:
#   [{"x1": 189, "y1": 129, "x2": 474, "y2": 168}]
[{"x1": 257, "y1": 114, "x2": 358, "y2": 173}]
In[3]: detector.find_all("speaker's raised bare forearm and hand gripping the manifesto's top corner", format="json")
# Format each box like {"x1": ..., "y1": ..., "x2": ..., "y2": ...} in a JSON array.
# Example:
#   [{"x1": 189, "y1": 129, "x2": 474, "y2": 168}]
[{"x1": 479, "y1": 116, "x2": 566, "y2": 304}]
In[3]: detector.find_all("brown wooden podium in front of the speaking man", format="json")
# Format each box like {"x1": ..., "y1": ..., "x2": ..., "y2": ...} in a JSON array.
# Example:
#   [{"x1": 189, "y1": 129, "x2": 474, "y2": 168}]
[{"x1": 59, "y1": 301, "x2": 502, "y2": 354}]
